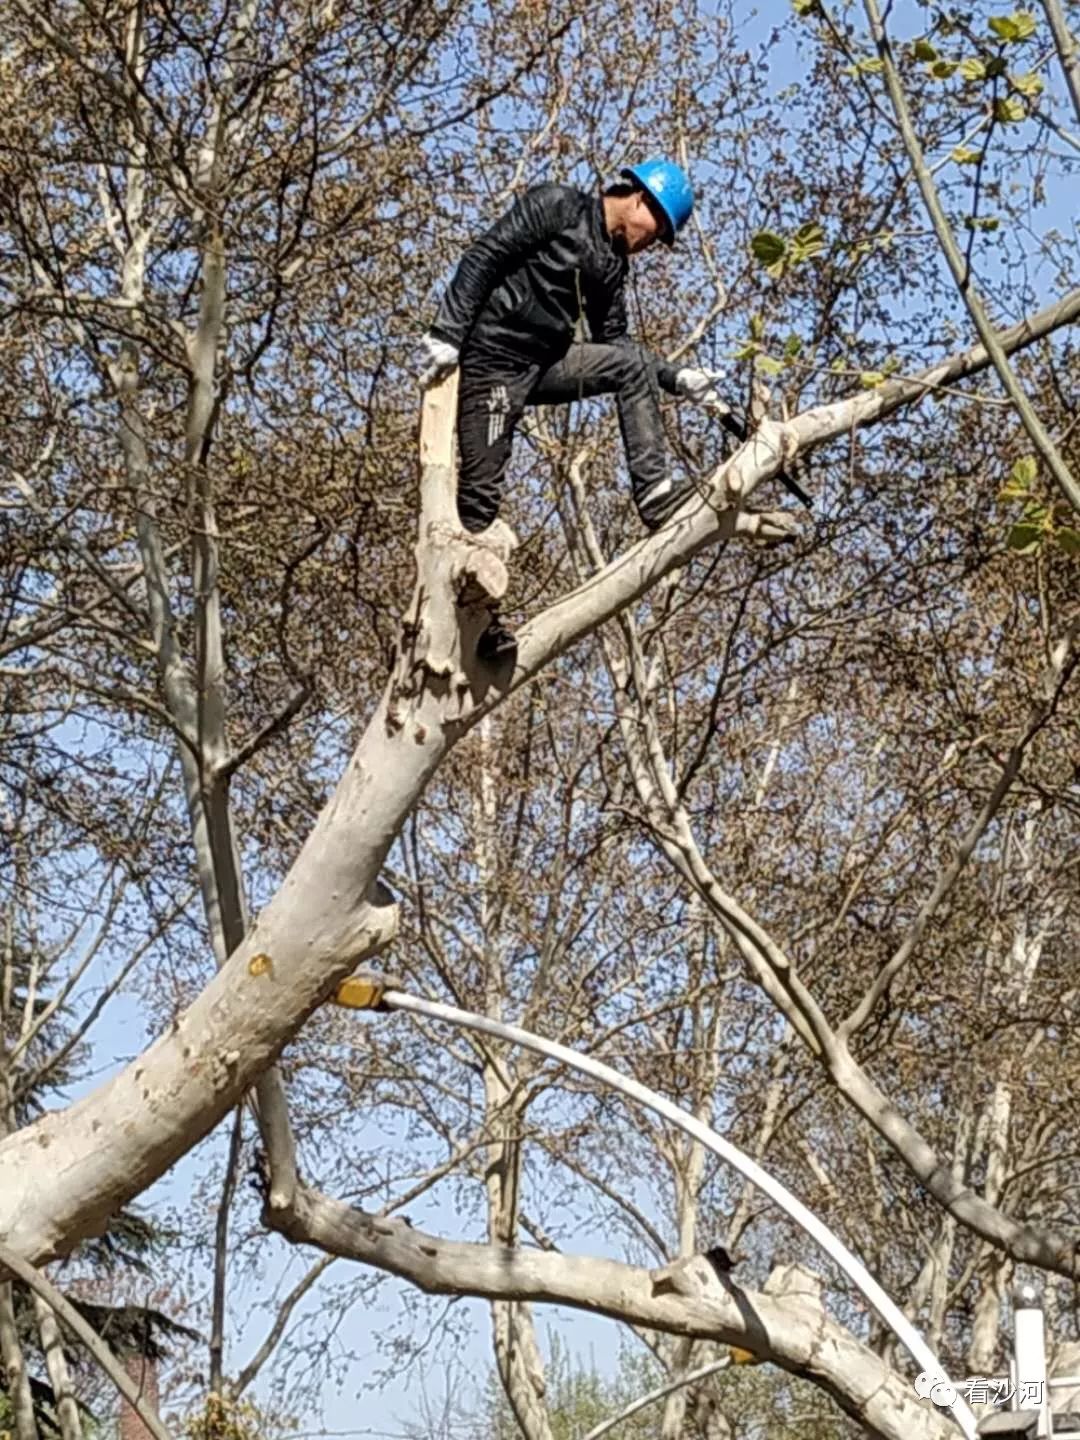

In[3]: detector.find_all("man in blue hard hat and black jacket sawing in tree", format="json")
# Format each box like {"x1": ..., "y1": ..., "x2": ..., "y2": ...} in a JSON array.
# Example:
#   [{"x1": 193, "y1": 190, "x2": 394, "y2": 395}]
[{"x1": 420, "y1": 160, "x2": 727, "y2": 531}]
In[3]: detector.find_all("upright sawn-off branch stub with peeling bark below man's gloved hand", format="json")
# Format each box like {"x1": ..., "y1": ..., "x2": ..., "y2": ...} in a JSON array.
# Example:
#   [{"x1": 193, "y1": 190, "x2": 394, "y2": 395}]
[{"x1": 387, "y1": 370, "x2": 517, "y2": 729}]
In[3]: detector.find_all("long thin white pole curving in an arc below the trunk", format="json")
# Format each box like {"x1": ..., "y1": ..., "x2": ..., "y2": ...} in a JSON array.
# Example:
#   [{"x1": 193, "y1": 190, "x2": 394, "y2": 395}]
[{"x1": 382, "y1": 989, "x2": 978, "y2": 1440}]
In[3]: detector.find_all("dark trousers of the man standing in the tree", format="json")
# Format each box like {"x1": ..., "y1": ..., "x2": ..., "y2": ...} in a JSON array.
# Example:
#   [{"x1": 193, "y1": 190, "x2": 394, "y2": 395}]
[{"x1": 458, "y1": 343, "x2": 674, "y2": 531}]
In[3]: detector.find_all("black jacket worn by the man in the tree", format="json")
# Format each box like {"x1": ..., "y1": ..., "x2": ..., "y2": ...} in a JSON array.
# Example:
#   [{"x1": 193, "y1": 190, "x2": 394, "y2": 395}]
[{"x1": 432, "y1": 184, "x2": 642, "y2": 366}]
